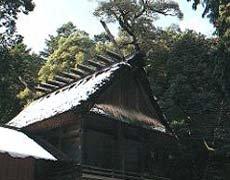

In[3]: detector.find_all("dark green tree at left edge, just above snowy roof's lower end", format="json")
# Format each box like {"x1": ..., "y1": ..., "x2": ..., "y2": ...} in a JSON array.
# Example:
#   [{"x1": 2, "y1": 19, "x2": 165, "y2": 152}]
[{"x1": 0, "y1": 44, "x2": 42, "y2": 123}]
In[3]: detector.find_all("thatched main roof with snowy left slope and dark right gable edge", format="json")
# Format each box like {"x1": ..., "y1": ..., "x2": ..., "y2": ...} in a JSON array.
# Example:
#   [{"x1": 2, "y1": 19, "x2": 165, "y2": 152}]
[{"x1": 7, "y1": 53, "x2": 172, "y2": 133}]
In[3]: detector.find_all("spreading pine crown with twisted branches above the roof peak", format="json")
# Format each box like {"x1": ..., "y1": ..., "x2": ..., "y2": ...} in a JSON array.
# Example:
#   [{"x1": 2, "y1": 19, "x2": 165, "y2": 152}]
[{"x1": 94, "y1": 0, "x2": 183, "y2": 50}]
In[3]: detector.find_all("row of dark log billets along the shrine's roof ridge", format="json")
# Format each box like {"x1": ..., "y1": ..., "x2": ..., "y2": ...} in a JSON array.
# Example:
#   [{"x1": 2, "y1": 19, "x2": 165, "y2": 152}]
[{"x1": 35, "y1": 50, "x2": 123, "y2": 98}]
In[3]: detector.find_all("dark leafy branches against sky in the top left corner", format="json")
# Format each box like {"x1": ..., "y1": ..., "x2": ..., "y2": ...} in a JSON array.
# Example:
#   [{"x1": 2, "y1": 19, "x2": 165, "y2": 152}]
[{"x1": 0, "y1": 0, "x2": 34, "y2": 46}]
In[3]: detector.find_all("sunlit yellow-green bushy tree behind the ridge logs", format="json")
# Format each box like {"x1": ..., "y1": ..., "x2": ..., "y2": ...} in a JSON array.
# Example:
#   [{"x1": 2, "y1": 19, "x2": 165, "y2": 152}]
[{"x1": 38, "y1": 23, "x2": 94, "y2": 81}]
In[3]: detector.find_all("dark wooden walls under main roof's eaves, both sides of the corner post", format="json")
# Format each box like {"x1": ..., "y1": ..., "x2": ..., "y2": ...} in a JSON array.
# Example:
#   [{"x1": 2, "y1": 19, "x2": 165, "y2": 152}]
[{"x1": 32, "y1": 112, "x2": 177, "y2": 177}]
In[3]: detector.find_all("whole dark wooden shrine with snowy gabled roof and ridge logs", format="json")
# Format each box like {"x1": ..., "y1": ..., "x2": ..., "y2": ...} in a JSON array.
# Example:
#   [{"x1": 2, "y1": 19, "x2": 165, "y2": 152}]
[{"x1": 7, "y1": 51, "x2": 178, "y2": 180}]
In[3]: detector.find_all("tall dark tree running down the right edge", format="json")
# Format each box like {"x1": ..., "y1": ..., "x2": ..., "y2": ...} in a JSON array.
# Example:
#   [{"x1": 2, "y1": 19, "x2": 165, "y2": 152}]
[{"x1": 187, "y1": 0, "x2": 230, "y2": 150}]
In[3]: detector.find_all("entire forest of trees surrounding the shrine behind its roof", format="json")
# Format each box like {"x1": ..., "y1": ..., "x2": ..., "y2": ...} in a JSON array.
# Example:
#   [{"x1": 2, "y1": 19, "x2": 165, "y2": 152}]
[{"x1": 0, "y1": 0, "x2": 230, "y2": 179}]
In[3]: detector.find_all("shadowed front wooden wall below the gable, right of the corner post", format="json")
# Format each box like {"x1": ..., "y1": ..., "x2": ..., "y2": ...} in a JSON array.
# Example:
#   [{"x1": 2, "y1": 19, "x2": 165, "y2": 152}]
[{"x1": 82, "y1": 113, "x2": 177, "y2": 175}]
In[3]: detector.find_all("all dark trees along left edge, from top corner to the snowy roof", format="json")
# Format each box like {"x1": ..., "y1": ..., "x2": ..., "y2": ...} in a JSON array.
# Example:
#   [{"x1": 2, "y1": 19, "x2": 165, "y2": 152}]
[{"x1": 0, "y1": 0, "x2": 42, "y2": 123}]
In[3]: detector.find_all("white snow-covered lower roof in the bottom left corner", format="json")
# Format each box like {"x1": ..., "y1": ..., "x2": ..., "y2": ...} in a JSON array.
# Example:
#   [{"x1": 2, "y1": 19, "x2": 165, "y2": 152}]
[{"x1": 0, "y1": 127, "x2": 57, "y2": 161}]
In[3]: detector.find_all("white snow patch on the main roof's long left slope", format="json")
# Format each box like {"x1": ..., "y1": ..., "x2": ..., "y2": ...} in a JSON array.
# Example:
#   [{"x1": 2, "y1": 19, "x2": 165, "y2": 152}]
[{"x1": 7, "y1": 62, "x2": 128, "y2": 128}]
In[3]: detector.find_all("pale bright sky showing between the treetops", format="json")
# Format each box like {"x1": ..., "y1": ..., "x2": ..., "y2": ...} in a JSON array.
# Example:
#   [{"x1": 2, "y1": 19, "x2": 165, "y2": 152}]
[{"x1": 17, "y1": 0, "x2": 214, "y2": 53}]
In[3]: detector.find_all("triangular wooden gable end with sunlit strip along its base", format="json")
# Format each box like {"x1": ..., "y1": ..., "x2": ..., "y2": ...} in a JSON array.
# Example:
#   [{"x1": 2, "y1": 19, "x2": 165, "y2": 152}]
[{"x1": 95, "y1": 69, "x2": 163, "y2": 127}]
